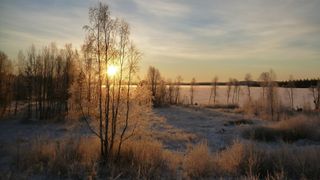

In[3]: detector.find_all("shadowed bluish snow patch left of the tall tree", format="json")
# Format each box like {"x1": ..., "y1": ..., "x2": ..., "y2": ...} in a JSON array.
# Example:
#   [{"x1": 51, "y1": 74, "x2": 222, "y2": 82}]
[{"x1": 0, "y1": 118, "x2": 93, "y2": 171}]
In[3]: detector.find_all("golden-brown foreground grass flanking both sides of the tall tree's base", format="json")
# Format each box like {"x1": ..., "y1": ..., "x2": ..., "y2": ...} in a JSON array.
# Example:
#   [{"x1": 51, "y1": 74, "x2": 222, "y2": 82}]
[{"x1": 5, "y1": 137, "x2": 176, "y2": 179}]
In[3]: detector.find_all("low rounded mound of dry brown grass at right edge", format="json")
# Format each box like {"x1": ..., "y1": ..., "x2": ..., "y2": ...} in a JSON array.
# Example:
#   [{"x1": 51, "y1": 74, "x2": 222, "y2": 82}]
[{"x1": 243, "y1": 116, "x2": 320, "y2": 142}]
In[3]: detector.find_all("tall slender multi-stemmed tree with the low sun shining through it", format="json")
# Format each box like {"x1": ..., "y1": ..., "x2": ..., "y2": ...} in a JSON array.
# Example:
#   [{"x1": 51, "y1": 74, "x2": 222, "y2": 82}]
[{"x1": 79, "y1": 3, "x2": 141, "y2": 162}]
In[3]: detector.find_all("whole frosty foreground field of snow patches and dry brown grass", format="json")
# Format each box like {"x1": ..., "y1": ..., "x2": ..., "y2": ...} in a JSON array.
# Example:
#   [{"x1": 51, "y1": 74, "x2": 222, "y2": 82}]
[{"x1": 0, "y1": 106, "x2": 320, "y2": 179}]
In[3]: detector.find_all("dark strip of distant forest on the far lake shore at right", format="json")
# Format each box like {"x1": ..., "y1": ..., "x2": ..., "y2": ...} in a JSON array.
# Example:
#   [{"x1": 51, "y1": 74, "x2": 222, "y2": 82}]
[{"x1": 175, "y1": 78, "x2": 320, "y2": 88}]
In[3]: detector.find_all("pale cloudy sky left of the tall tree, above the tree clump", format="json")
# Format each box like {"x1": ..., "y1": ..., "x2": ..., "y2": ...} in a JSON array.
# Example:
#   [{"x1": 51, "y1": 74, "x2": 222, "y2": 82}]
[{"x1": 0, "y1": 1, "x2": 88, "y2": 58}]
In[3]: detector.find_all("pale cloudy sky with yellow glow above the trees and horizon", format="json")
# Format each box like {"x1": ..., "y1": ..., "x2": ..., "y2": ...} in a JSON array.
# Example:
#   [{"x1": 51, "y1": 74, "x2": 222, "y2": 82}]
[{"x1": 0, "y1": 0, "x2": 320, "y2": 82}]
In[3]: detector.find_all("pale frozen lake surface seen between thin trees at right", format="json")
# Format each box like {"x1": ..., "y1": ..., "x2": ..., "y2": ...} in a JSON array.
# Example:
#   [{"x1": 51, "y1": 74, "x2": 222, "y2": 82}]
[{"x1": 181, "y1": 86, "x2": 314, "y2": 108}]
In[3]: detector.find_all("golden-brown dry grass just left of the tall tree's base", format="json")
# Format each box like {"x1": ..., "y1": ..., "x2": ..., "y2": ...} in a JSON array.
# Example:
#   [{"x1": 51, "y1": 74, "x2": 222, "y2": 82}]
[{"x1": 14, "y1": 138, "x2": 99, "y2": 178}]
